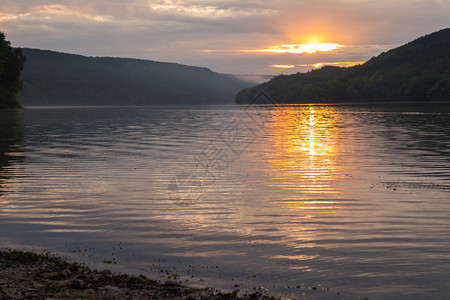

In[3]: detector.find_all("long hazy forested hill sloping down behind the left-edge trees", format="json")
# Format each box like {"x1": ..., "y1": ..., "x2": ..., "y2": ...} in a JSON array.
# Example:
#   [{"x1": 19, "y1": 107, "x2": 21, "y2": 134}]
[{"x1": 19, "y1": 48, "x2": 255, "y2": 106}]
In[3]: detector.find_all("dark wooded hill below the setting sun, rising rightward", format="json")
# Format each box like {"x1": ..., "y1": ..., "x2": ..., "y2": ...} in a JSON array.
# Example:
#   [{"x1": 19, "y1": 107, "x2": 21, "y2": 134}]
[{"x1": 235, "y1": 28, "x2": 450, "y2": 104}]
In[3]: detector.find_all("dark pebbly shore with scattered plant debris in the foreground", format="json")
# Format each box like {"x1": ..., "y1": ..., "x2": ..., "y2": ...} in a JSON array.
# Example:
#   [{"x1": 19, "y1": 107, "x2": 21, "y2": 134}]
[{"x1": 0, "y1": 251, "x2": 275, "y2": 300}]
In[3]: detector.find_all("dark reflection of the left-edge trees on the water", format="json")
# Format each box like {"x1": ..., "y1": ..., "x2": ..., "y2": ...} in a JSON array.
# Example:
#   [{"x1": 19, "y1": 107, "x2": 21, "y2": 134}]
[{"x1": 0, "y1": 111, "x2": 23, "y2": 196}]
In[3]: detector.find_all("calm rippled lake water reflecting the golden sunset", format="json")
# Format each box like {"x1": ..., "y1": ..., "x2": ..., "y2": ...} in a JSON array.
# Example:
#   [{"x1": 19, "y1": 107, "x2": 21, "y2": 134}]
[{"x1": 0, "y1": 104, "x2": 450, "y2": 299}]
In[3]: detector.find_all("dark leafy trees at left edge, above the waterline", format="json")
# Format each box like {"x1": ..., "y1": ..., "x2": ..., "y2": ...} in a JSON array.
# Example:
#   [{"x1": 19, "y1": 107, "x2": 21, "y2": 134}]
[{"x1": 0, "y1": 32, "x2": 25, "y2": 109}]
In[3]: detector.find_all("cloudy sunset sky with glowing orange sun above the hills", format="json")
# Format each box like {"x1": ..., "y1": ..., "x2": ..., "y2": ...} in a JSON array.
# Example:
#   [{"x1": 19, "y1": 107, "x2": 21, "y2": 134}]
[{"x1": 0, "y1": 0, "x2": 450, "y2": 75}]
